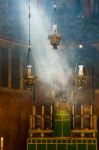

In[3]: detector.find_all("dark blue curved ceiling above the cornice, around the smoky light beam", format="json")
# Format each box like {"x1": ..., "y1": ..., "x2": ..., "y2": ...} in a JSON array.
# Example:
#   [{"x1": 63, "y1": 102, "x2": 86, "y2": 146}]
[{"x1": 0, "y1": 0, "x2": 99, "y2": 42}]
